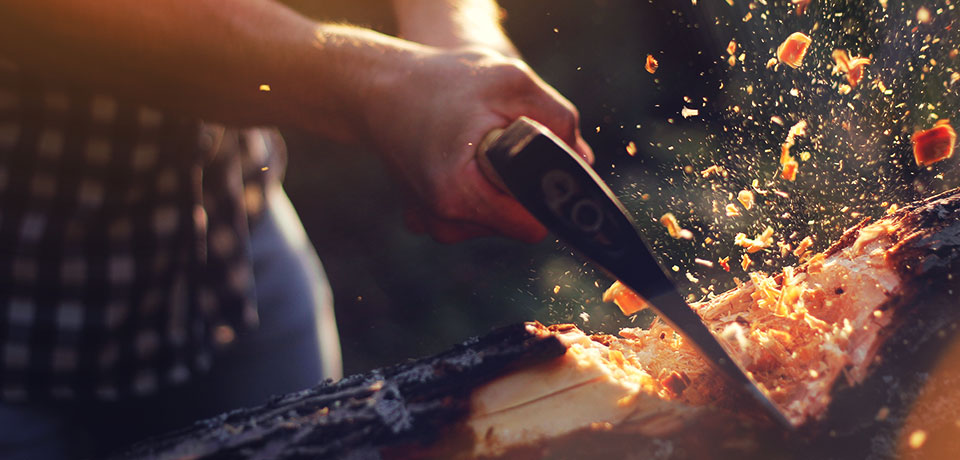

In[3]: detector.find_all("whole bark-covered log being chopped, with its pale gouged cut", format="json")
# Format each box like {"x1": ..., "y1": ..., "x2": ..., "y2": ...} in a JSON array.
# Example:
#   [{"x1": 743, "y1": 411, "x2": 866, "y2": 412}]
[{"x1": 117, "y1": 189, "x2": 960, "y2": 459}]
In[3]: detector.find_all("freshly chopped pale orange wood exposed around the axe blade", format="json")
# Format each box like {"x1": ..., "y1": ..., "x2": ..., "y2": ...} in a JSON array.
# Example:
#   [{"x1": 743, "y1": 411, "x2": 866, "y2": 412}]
[{"x1": 468, "y1": 186, "x2": 960, "y2": 457}]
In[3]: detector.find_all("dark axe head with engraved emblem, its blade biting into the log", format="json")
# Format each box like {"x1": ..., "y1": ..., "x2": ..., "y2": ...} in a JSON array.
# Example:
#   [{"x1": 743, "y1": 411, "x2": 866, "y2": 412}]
[{"x1": 477, "y1": 117, "x2": 793, "y2": 428}]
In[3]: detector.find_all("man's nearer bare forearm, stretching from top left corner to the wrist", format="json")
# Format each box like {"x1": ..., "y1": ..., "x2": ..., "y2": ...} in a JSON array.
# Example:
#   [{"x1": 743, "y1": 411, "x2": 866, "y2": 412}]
[{"x1": 0, "y1": 0, "x2": 426, "y2": 140}]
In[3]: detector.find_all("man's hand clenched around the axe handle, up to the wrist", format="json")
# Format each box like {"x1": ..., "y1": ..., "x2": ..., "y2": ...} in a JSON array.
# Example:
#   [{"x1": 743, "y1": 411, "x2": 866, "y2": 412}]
[{"x1": 365, "y1": 48, "x2": 593, "y2": 242}]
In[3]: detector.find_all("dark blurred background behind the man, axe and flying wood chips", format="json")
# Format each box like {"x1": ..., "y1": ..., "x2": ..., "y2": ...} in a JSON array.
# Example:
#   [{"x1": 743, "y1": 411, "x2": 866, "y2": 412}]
[{"x1": 285, "y1": 0, "x2": 960, "y2": 374}]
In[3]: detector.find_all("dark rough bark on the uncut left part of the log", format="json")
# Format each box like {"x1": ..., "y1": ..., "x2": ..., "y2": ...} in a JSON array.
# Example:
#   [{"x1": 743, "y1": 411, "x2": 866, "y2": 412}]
[{"x1": 113, "y1": 324, "x2": 566, "y2": 460}]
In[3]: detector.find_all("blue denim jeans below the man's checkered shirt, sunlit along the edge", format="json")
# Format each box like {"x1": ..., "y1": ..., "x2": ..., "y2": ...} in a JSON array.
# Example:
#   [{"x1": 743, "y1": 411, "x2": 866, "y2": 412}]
[{"x1": 0, "y1": 184, "x2": 341, "y2": 460}]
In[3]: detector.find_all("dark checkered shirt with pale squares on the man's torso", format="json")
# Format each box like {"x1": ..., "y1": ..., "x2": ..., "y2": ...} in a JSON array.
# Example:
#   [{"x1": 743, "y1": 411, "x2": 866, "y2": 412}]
[{"x1": 0, "y1": 60, "x2": 283, "y2": 402}]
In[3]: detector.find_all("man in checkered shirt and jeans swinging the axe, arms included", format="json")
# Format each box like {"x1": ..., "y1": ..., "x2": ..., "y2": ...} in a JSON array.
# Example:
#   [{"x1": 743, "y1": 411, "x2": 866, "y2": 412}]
[{"x1": 0, "y1": 0, "x2": 592, "y2": 458}]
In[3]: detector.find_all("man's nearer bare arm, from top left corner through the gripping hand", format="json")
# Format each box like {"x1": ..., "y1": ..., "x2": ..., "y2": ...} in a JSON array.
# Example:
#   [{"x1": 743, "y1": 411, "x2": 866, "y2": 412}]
[{"x1": 0, "y1": 0, "x2": 591, "y2": 241}]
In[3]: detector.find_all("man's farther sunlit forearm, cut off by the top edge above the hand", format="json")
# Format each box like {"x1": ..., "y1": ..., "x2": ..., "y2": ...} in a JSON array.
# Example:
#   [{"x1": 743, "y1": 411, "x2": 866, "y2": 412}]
[{"x1": 393, "y1": 0, "x2": 518, "y2": 57}]
